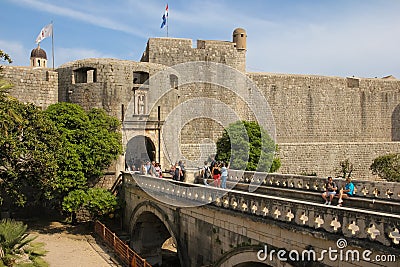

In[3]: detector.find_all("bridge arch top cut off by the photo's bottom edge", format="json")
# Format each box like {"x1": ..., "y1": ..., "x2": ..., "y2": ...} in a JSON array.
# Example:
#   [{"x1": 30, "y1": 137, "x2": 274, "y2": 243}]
[{"x1": 214, "y1": 245, "x2": 292, "y2": 267}]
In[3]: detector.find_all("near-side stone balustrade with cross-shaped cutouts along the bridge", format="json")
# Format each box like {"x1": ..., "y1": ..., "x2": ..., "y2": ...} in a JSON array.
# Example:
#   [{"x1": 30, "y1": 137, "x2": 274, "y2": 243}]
[{"x1": 123, "y1": 174, "x2": 400, "y2": 247}]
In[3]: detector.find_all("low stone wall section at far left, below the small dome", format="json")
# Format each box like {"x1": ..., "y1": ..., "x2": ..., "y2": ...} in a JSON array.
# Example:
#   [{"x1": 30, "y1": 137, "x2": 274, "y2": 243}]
[{"x1": 2, "y1": 66, "x2": 58, "y2": 108}]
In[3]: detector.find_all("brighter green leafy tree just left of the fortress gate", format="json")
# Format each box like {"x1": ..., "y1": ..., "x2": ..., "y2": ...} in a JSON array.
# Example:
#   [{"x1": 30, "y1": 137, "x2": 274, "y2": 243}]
[{"x1": 45, "y1": 103, "x2": 122, "y2": 196}]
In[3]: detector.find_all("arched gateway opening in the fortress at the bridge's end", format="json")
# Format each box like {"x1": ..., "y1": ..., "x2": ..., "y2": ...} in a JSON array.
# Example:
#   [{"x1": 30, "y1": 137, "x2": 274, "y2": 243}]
[{"x1": 125, "y1": 135, "x2": 156, "y2": 170}]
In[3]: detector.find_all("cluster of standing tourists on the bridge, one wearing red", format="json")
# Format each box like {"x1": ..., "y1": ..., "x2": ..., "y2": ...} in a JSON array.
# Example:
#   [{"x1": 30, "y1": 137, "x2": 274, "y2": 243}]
[{"x1": 201, "y1": 158, "x2": 229, "y2": 189}]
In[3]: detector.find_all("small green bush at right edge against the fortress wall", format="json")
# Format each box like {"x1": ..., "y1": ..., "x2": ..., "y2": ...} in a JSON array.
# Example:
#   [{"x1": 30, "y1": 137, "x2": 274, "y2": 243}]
[{"x1": 370, "y1": 154, "x2": 400, "y2": 182}]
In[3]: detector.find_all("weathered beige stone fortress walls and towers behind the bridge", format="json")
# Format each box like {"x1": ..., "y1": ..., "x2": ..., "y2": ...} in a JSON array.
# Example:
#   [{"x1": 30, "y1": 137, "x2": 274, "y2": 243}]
[{"x1": 4, "y1": 28, "x2": 400, "y2": 179}]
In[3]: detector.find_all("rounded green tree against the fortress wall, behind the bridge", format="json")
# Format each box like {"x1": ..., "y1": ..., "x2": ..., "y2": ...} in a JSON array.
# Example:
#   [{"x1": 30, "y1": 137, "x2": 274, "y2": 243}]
[{"x1": 216, "y1": 121, "x2": 280, "y2": 172}]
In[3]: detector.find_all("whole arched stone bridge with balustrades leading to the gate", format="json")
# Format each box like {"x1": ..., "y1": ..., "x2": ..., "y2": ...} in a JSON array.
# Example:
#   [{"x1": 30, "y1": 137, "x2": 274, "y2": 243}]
[{"x1": 123, "y1": 171, "x2": 400, "y2": 267}]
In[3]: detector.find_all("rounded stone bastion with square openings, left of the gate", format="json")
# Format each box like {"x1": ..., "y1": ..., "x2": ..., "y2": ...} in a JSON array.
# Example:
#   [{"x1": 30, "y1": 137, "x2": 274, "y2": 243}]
[{"x1": 57, "y1": 59, "x2": 161, "y2": 119}]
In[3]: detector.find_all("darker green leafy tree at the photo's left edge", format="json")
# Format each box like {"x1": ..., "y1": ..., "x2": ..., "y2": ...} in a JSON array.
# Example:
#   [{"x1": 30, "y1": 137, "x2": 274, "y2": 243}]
[{"x1": 0, "y1": 98, "x2": 61, "y2": 206}]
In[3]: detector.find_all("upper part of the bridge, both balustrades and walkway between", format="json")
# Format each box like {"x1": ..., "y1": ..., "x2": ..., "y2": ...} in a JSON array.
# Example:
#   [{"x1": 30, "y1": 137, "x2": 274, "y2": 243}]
[{"x1": 124, "y1": 175, "x2": 400, "y2": 250}]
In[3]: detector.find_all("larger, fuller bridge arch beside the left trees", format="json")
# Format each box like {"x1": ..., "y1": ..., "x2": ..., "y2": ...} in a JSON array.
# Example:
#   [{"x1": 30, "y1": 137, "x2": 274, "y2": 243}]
[{"x1": 129, "y1": 201, "x2": 188, "y2": 267}]
